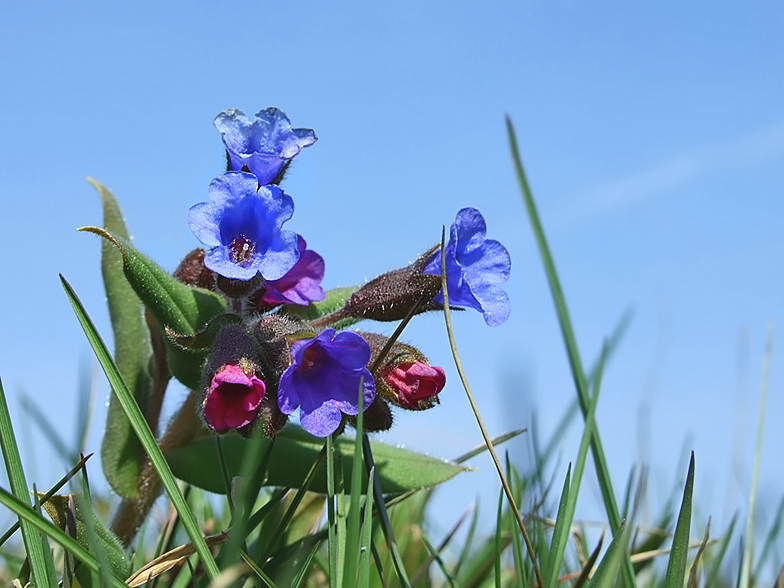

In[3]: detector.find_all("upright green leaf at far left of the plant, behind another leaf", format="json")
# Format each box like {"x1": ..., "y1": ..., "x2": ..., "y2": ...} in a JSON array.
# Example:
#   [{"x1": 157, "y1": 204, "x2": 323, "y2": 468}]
[{"x1": 87, "y1": 178, "x2": 152, "y2": 499}]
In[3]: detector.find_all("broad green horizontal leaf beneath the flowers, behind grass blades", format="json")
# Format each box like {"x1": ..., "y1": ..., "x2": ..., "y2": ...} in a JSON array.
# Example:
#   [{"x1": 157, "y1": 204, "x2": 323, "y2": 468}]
[{"x1": 165, "y1": 424, "x2": 470, "y2": 494}]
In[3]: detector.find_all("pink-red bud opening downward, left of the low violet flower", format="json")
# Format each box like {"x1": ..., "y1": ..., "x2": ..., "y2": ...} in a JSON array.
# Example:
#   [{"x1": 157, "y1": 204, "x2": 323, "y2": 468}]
[{"x1": 202, "y1": 364, "x2": 266, "y2": 432}]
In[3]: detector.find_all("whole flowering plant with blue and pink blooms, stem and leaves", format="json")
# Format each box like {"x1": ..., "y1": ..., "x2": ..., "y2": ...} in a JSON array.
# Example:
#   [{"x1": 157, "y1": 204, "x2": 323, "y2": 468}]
[{"x1": 70, "y1": 108, "x2": 510, "y2": 543}]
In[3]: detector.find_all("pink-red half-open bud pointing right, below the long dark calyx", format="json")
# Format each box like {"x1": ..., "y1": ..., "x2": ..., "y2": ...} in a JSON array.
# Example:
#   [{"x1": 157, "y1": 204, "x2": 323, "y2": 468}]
[{"x1": 381, "y1": 361, "x2": 446, "y2": 410}]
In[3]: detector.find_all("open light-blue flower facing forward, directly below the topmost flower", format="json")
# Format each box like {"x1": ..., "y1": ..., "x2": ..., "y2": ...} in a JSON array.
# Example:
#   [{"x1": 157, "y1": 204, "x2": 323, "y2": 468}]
[{"x1": 188, "y1": 172, "x2": 299, "y2": 280}]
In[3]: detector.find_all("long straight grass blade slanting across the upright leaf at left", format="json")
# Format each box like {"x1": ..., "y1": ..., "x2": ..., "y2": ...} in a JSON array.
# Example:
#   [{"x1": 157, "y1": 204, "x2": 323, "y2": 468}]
[{"x1": 60, "y1": 276, "x2": 219, "y2": 579}]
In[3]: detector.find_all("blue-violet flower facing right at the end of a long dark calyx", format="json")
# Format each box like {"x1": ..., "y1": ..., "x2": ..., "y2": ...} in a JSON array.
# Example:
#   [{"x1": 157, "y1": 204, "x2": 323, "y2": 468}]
[{"x1": 422, "y1": 208, "x2": 512, "y2": 327}]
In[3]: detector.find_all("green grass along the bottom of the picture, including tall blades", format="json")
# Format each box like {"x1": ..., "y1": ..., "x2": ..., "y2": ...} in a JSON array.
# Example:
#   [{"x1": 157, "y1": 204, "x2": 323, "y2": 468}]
[{"x1": 0, "y1": 116, "x2": 784, "y2": 588}]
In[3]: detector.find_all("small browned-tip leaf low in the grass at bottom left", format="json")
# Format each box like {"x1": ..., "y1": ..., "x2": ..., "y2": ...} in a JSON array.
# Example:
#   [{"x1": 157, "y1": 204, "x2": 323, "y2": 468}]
[{"x1": 40, "y1": 494, "x2": 131, "y2": 587}]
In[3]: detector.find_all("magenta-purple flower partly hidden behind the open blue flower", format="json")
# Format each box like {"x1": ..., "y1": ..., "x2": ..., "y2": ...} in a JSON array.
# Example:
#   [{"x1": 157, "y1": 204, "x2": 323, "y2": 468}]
[{"x1": 259, "y1": 235, "x2": 324, "y2": 306}]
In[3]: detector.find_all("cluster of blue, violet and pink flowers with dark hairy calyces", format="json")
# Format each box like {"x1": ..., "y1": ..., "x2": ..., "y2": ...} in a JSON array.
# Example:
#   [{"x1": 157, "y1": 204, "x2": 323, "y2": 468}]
[{"x1": 175, "y1": 108, "x2": 510, "y2": 437}]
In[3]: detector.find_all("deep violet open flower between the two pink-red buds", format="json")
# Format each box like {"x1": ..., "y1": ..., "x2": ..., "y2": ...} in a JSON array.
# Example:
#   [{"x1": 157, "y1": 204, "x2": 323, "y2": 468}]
[{"x1": 278, "y1": 329, "x2": 376, "y2": 437}]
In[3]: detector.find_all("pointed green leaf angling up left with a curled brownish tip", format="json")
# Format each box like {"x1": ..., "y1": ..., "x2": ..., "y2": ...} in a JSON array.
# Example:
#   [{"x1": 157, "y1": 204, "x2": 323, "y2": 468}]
[{"x1": 79, "y1": 227, "x2": 226, "y2": 389}]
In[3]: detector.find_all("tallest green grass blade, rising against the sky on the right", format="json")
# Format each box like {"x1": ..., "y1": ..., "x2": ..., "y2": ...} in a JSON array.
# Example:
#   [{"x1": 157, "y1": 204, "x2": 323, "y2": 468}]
[{"x1": 506, "y1": 117, "x2": 636, "y2": 587}]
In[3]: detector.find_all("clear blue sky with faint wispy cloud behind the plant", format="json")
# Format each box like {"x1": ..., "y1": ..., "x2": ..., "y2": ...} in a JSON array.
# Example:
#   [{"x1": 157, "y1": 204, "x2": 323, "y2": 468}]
[{"x1": 0, "y1": 2, "x2": 784, "y2": 568}]
